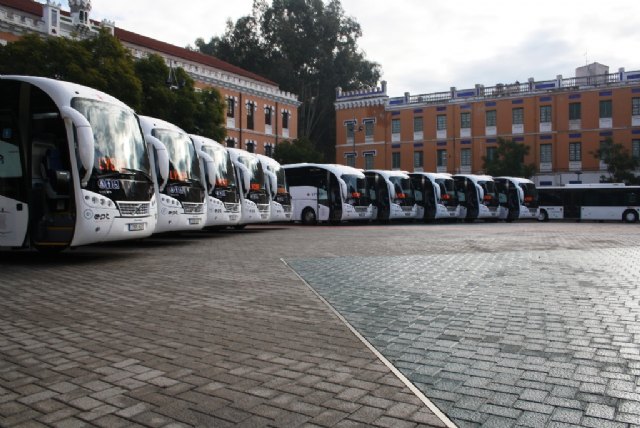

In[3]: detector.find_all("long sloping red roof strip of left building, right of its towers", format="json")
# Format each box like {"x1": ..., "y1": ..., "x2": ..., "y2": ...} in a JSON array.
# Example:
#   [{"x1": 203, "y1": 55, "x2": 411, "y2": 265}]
[{"x1": 115, "y1": 27, "x2": 278, "y2": 87}]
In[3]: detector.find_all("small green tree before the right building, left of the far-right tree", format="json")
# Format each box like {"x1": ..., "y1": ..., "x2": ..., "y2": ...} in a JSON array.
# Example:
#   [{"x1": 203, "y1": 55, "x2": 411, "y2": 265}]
[{"x1": 482, "y1": 138, "x2": 536, "y2": 178}]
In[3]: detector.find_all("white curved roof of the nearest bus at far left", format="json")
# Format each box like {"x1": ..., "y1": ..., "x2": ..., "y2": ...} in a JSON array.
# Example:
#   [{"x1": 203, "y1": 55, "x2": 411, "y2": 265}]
[{"x1": 0, "y1": 75, "x2": 133, "y2": 111}]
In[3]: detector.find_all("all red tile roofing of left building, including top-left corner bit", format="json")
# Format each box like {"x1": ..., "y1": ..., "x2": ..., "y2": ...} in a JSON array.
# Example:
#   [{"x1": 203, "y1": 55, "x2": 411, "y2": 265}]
[{"x1": 0, "y1": 0, "x2": 278, "y2": 87}]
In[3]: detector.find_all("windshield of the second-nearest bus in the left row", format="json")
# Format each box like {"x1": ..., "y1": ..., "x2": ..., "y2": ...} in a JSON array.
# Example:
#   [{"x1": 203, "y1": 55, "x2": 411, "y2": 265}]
[{"x1": 153, "y1": 129, "x2": 200, "y2": 182}]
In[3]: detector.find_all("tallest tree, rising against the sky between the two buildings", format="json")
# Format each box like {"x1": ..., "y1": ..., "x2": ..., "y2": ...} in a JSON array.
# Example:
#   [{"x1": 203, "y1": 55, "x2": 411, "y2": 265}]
[{"x1": 195, "y1": 0, "x2": 380, "y2": 160}]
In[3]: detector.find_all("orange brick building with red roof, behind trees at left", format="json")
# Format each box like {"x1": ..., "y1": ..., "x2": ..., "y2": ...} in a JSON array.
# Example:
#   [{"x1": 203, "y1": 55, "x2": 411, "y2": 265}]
[{"x1": 0, "y1": 0, "x2": 301, "y2": 156}]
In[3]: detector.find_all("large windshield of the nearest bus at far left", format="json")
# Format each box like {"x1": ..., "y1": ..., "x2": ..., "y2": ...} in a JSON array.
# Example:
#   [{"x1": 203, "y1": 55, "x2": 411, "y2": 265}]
[{"x1": 71, "y1": 98, "x2": 151, "y2": 178}]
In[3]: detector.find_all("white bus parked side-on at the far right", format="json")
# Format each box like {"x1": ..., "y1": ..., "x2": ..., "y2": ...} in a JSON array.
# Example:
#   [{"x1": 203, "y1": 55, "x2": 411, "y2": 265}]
[{"x1": 538, "y1": 183, "x2": 640, "y2": 223}]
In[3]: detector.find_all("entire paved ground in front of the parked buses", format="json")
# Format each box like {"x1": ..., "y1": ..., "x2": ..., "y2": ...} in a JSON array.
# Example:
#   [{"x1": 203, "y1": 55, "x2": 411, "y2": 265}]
[{"x1": 0, "y1": 222, "x2": 640, "y2": 428}]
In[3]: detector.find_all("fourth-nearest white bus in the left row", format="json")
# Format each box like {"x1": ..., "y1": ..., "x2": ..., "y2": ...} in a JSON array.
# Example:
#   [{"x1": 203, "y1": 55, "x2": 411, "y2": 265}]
[{"x1": 227, "y1": 148, "x2": 271, "y2": 229}]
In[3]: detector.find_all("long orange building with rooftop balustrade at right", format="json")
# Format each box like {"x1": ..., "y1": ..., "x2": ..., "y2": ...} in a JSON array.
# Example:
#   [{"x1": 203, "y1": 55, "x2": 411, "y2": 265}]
[{"x1": 335, "y1": 63, "x2": 640, "y2": 184}]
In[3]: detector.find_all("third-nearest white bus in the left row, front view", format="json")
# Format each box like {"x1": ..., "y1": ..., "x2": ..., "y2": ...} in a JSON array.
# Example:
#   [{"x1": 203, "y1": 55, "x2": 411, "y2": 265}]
[{"x1": 191, "y1": 135, "x2": 241, "y2": 227}]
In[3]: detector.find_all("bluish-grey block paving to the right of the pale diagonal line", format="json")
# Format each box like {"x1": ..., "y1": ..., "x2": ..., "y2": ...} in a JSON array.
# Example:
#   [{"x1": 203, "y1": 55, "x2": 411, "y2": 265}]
[{"x1": 288, "y1": 224, "x2": 640, "y2": 427}]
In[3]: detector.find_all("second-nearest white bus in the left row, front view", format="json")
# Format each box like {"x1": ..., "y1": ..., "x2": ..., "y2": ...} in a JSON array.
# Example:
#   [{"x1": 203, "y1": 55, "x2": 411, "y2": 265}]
[{"x1": 140, "y1": 116, "x2": 207, "y2": 233}]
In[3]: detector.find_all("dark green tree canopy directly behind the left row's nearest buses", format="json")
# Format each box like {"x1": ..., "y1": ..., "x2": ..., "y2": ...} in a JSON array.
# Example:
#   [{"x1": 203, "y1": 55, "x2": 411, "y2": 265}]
[{"x1": 0, "y1": 31, "x2": 226, "y2": 141}]
